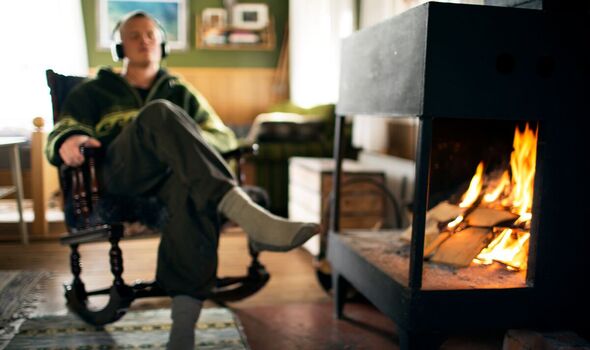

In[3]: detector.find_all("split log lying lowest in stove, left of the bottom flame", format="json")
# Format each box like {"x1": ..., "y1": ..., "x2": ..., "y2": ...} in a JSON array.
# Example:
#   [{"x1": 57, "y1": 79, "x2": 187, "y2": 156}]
[{"x1": 430, "y1": 227, "x2": 493, "y2": 267}]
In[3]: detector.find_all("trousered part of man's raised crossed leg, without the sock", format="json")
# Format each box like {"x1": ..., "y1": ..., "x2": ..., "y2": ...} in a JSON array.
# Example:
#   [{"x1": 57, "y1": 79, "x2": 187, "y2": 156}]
[{"x1": 104, "y1": 100, "x2": 235, "y2": 210}]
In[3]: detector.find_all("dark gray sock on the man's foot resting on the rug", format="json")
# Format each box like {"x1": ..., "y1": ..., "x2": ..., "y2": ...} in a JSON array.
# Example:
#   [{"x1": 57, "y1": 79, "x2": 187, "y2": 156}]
[{"x1": 167, "y1": 295, "x2": 203, "y2": 350}]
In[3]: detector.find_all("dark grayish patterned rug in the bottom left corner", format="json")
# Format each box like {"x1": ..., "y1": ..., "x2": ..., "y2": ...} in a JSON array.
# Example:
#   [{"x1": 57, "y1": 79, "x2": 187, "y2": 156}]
[{"x1": 0, "y1": 271, "x2": 51, "y2": 349}]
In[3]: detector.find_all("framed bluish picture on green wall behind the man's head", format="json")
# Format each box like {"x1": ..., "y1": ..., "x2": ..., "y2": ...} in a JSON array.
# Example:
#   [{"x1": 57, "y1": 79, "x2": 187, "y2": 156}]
[{"x1": 97, "y1": 0, "x2": 188, "y2": 50}]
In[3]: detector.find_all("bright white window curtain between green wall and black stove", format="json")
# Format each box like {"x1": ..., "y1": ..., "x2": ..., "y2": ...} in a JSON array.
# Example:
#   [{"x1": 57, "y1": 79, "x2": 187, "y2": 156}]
[{"x1": 289, "y1": 0, "x2": 354, "y2": 106}]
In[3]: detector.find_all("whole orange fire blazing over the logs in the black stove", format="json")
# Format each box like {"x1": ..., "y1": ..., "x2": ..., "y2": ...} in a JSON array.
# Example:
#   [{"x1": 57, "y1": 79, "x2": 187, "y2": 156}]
[{"x1": 447, "y1": 123, "x2": 537, "y2": 270}]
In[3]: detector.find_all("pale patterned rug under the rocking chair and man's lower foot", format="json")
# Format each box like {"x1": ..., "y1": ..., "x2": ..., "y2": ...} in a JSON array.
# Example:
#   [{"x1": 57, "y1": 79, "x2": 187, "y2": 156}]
[{"x1": 6, "y1": 308, "x2": 248, "y2": 350}]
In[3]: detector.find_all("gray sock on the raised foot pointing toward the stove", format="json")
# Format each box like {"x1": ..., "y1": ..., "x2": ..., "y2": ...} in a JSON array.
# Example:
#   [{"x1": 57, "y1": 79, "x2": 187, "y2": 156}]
[{"x1": 218, "y1": 187, "x2": 320, "y2": 251}]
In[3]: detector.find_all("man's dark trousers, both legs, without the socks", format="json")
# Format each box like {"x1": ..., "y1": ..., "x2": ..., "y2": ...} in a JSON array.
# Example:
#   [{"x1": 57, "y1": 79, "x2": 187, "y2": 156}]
[{"x1": 103, "y1": 100, "x2": 235, "y2": 299}]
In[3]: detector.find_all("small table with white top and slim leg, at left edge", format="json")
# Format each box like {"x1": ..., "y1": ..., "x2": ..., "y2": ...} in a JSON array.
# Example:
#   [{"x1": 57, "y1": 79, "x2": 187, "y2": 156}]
[{"x1": 0, "y1": 137, "x2": 29, "y2": 244}]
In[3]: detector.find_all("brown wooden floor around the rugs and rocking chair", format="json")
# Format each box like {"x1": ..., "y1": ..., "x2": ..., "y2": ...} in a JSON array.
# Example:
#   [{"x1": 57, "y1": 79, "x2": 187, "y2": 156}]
[{"x1": 0, "y1": 230, "x2": 508, "y2": 350}]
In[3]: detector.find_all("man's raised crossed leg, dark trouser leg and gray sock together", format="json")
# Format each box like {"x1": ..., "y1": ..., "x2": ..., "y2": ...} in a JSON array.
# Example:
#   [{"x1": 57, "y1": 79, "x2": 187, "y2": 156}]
[{"x1": 107, "y1": 100, "x2": 319, "y2": 251}]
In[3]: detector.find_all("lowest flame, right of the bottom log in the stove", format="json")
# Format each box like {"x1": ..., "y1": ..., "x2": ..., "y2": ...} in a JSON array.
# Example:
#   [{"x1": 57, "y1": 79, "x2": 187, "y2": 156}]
[{"x1": 476, "y1": 228, "x2": 531, "y2": 270}]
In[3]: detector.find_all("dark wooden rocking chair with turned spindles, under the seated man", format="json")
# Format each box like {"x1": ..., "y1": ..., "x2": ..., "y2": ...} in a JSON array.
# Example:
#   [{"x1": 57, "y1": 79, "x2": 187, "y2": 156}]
[{"x1": 46, "y1": 70, "x2": 270, "y2": 326}]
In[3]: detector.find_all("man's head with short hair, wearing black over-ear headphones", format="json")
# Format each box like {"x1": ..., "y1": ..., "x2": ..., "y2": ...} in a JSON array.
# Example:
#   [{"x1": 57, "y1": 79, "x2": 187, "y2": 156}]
[{"x1": 112, "y1": 11, "x2": 168, "y2": 65}]
